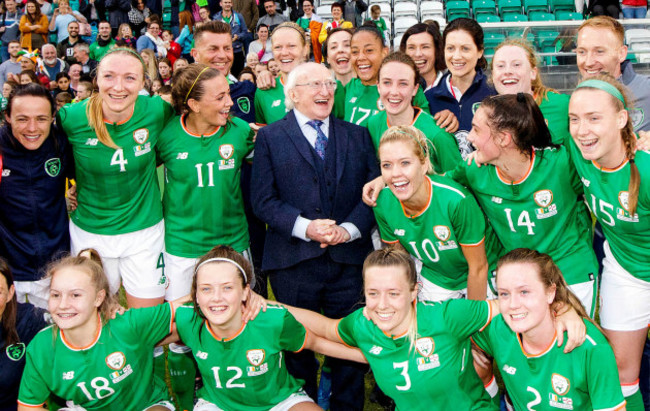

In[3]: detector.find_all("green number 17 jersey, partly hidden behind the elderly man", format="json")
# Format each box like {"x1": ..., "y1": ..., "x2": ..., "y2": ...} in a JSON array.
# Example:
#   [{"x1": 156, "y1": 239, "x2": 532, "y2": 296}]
[{"x1": 336, "y1": 78, "x2": 429, "y2": 127}]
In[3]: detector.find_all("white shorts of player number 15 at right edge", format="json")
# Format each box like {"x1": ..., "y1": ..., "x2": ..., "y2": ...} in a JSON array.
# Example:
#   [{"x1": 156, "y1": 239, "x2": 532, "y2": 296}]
[{"x1": 600, "y1": 241, "x2": 650, "y2": 331}]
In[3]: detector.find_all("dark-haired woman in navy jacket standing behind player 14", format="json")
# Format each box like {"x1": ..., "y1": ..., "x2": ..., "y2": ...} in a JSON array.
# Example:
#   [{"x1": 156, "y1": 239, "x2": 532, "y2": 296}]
[{"x1": 425, "y1": 18, "x2": 496, "y2": 158}]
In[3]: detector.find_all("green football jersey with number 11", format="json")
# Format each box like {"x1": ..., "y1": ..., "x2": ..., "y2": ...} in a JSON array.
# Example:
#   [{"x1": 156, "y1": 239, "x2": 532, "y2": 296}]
[{"x1": 158, "y1": 116, "x2": 254, "y2": 258}]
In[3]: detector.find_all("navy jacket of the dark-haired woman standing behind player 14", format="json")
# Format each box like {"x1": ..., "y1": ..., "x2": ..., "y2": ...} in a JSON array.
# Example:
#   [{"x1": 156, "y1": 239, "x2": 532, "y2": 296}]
[{"x1": 424, "y1": 68, "x2": 497, "y2": 158}]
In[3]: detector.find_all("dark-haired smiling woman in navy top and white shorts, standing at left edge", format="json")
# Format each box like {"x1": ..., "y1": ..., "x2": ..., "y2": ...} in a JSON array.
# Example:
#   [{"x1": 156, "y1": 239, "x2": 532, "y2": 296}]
[{"x1": 0, "y1": 84, "x2": 74, "y2": 308}]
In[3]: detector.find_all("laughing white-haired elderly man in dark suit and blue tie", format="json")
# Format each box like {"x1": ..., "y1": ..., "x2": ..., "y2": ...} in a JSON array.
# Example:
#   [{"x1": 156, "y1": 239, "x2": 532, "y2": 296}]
[{"x1": 252, "y1": 63, "x2": 379, "y2": 410}]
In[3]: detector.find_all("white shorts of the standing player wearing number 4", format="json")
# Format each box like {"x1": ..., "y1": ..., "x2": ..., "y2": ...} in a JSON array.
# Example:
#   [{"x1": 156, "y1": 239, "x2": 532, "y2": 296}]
[{"x1": 70, "y1": 221, "x2": 167, "y2": 298}]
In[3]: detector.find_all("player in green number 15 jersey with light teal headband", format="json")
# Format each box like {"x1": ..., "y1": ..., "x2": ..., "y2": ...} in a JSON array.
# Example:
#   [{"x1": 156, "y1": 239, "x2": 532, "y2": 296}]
[{"x1": 569, "y1": 76, "x2": 650, "y2": 409}]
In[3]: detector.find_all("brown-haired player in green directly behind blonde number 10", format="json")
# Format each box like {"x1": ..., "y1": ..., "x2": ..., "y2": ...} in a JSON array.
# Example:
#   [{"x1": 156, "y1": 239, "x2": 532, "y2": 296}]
[{"x1": 368, "y1": 52, "x2": 462, "y2": 174}]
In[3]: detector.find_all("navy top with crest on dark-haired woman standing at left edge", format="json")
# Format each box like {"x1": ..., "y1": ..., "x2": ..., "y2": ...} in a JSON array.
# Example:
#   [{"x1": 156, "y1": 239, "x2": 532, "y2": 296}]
[{"x1": 0, "y1": 125, "x2": 74, "y2": 281}]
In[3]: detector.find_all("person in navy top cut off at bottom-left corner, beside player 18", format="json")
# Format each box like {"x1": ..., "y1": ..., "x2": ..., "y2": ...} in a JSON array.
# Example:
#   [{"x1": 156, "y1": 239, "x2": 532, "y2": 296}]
[{"x1": 0, "y1": 258, "x2": 46, "y2": 411}]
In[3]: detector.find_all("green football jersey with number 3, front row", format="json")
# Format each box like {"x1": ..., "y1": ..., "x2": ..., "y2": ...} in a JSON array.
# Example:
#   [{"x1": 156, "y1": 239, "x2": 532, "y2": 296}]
[{"x1": 337, "y1": 300, "x2": 495, "y2": 411}]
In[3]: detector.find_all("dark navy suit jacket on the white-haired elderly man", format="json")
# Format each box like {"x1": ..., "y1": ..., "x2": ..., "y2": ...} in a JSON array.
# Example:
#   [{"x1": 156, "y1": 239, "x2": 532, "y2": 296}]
[{"x1": 251, "y1": 111, "x2": 379, "y2": 270}]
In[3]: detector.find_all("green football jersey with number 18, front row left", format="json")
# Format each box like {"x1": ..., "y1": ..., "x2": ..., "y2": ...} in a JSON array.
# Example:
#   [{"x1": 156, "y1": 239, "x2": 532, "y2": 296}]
[{"x1": 18, "y1": 304, "x2": 173, "y2": 411}]
